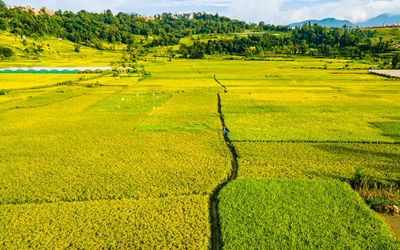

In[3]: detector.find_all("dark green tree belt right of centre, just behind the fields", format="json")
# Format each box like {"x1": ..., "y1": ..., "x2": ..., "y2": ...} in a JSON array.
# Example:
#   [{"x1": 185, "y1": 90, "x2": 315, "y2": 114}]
[{"x1": 179, "y1": 24, "x2": 393, "y2": 58}]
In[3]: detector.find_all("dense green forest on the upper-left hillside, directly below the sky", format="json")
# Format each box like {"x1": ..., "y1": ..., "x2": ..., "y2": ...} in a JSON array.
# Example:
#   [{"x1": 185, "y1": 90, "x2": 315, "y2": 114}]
[{"x1": 0, "y1": 1, "x2": 260, "y2": 46}]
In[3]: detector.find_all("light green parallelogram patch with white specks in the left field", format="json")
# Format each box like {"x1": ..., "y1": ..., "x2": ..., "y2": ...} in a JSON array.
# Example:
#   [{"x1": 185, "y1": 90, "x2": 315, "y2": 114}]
[{"x1": 86, "y1": 93, "x2": 171, "y2": 114}]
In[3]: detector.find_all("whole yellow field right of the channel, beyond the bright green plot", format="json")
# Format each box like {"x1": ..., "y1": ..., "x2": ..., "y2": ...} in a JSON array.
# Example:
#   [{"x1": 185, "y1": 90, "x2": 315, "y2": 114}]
[{"x1": 212, "y1": 59, "x2": 400, "y2": 181}]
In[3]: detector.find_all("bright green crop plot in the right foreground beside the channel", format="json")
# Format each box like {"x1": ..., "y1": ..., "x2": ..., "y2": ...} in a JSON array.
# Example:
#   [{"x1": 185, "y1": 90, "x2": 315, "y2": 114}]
[{"x1": 219, "y1": 179, "x2": 399, "y2": 249}]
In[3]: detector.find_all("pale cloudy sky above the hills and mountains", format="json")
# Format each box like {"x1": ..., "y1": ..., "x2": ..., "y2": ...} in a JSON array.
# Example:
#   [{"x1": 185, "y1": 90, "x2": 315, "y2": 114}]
[{"x1": 5, "y1": 0, "x2": 400, "y2": 24}]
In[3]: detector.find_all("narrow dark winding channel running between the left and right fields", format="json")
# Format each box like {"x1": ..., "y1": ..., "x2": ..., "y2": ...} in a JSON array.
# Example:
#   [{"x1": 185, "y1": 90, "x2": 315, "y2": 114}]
[{"x1": 210, "y1": 92, "x2": 238, "y2": 250}]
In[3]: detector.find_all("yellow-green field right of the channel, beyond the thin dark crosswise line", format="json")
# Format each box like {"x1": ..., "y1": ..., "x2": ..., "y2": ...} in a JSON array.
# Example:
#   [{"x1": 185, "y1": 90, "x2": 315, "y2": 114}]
[{"x1": 216, "y1": 60, "x2": 400, "y2": 142}]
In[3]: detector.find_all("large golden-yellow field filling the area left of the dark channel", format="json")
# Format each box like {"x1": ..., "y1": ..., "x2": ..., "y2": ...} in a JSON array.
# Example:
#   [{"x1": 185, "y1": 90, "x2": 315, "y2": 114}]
[{"x1": 0, "y1": 65, "x2": 231, "y2": 248}]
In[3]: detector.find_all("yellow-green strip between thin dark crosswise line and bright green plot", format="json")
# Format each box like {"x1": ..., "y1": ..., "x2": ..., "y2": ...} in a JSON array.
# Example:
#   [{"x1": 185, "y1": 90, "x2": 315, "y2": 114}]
[{"x1": 234, "y1": 142, "x2": 400, "y2": 183}]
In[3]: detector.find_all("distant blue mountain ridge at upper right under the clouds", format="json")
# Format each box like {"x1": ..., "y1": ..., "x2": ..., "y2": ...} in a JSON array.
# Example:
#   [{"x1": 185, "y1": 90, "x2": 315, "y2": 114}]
[{"x1": 289, "y1": 14, "x2": 400, "y2": 28}]
